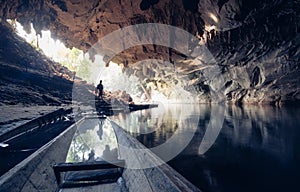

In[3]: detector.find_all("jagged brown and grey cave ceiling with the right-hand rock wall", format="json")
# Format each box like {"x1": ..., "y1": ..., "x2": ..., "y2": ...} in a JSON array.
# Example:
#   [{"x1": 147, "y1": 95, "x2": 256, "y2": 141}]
[{"x1": 0, "y1": 0, "x2": 300, "y2": 104}]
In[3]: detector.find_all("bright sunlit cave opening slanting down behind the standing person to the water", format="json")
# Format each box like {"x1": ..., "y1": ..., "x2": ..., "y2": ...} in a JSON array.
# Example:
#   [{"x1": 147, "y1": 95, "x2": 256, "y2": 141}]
[{"x1": 8, "y1": 20, "x2": 194, "y2": 103}]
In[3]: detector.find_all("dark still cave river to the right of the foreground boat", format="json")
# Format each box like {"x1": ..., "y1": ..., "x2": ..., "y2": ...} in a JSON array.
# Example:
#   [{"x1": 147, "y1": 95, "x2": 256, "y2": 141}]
[{"x1": 114, "y1": 104, "x2": 300, "y2": 192}]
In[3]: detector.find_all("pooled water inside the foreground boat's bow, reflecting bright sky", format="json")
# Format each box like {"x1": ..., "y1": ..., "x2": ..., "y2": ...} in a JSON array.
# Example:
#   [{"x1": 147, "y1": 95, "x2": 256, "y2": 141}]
[{"x1": 66, "y1": 118, "x2": 118, "y2": 162}]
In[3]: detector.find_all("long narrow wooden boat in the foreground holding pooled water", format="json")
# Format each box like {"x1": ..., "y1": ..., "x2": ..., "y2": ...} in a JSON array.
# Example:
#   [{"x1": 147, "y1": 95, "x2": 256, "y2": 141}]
[{"x1": 0, "y1": 112, "x2": 200, "y2": 192}]
